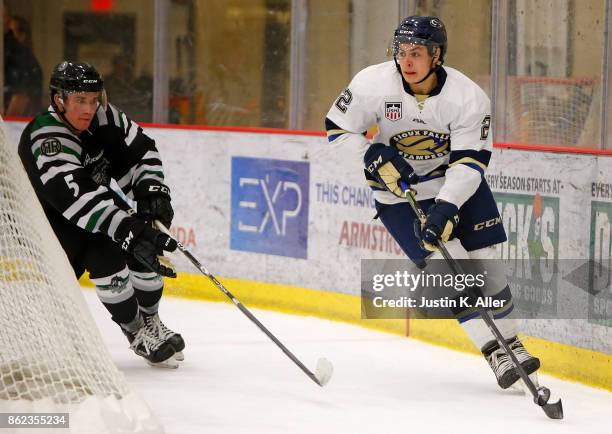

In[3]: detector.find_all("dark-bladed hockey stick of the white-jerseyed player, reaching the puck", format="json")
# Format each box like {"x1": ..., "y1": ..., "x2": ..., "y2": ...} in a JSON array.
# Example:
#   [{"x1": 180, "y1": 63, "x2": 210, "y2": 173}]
[{"x1": 400, "y1": 181, "x2": 563, "y2": 419}]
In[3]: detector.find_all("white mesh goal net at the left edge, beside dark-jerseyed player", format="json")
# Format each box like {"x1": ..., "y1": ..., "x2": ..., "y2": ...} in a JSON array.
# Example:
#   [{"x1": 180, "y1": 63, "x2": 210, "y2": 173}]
[{"x1": 0, "y1": 120, "x2": 162, "y2": 433}]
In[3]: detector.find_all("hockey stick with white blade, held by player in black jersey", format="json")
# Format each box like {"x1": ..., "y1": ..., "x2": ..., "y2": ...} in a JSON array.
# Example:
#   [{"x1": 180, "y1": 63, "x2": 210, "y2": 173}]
[{"x1": 155, "y1": 220, "x2": 334, "y2": 387}]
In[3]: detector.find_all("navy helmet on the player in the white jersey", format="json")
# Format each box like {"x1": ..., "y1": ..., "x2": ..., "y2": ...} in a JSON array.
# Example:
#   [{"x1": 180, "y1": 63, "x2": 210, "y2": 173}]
[{"x1": 393, "y1": 16, "x2": 448, "y2": 64}]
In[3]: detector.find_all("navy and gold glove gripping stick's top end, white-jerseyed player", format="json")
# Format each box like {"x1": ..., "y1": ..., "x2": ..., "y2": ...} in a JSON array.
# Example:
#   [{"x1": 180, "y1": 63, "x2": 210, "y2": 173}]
[{"x1": 363, "y1": 143, "x2": 419, "y2": 197}]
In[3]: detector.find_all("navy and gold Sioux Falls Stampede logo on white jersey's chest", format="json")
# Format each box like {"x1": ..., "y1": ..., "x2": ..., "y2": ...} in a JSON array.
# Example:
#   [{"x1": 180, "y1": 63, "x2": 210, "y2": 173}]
[{"x1": 389, "y1": 130, "x2": 450, "y2": 160}]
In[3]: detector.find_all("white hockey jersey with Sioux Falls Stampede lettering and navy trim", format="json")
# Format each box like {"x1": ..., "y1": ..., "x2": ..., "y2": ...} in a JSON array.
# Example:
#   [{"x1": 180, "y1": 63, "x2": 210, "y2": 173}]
[{"x1": 325, "y1": 61, "x2": 492, "y2": 207}]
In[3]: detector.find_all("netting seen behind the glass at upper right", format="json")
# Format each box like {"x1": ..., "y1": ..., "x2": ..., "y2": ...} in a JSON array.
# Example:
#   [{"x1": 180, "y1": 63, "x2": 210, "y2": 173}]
[{"x1": 506, "y1": 76, "x2": 600, "y2": 147}]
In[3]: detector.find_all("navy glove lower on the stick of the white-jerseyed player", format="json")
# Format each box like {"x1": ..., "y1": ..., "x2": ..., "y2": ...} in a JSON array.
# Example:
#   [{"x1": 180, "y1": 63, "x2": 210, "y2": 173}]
[{"x1": 414, "y1": 202, "x2": 459, "y2": 252}]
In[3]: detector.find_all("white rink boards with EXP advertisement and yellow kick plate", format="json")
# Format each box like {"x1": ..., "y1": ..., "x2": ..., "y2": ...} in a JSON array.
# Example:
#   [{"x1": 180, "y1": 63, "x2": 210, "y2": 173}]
[{"x1": 7, "y1": 122, "x2": 612, "y2": 390}]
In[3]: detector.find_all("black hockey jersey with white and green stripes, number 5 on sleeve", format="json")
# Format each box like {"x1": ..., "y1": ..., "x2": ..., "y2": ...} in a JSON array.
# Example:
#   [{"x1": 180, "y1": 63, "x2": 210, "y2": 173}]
[{"x1": 19, "y1": 104, "x2": 164, "y2": 239}]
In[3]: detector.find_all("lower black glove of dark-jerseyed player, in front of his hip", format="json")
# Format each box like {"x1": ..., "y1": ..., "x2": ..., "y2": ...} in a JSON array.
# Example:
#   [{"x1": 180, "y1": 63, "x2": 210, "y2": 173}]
[{"x1": 115, "y1": 217, "x2": 178, "y2": 277}]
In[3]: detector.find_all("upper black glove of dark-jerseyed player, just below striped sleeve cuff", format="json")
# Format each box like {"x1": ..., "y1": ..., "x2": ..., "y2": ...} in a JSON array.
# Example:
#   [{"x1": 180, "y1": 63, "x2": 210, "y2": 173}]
[{"x1": 134, "y1": 180, "x2": 174, "y2": 228}]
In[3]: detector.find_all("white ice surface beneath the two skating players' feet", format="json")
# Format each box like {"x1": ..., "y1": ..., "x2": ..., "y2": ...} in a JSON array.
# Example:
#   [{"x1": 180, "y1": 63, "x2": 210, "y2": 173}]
[{"x1": 85, "y1": 291, "x2": 612, "y2": 434}]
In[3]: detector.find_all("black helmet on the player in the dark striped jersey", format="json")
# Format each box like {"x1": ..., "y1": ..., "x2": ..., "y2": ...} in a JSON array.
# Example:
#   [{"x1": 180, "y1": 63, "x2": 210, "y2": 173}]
[{"x1": 49, "y1": 60, "x2": 106, "y2": 107}]
